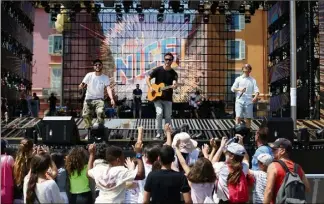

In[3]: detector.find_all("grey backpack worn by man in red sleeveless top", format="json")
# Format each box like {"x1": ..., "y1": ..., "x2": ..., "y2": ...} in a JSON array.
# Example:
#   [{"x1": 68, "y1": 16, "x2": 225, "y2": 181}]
[{"x1": 276, "y1": 160, "x2": 306, "y2": 203}]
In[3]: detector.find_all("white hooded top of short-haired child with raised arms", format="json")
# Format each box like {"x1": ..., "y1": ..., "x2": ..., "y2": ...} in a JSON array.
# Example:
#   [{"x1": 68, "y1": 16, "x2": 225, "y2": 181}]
[{"x1": 88, "y1": 165, "x2": 137, "y2": 203}]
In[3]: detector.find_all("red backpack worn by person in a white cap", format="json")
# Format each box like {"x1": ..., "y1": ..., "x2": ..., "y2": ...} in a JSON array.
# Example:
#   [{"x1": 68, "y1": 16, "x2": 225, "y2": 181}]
[{"x1": 228, "y1": 171, "x2": 249, "y2": 203}]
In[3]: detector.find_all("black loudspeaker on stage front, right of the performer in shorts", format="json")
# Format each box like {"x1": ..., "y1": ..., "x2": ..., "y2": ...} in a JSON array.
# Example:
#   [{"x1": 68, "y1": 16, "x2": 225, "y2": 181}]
[{"x1": 261, "y1": 117, "x2": 294, "y2": 142}]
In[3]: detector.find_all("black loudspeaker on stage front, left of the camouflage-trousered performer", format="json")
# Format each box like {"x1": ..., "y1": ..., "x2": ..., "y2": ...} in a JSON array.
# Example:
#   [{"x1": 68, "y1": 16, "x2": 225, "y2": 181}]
[{"x1": 42, "y1": 116, "x2": 80, "y2": 145}]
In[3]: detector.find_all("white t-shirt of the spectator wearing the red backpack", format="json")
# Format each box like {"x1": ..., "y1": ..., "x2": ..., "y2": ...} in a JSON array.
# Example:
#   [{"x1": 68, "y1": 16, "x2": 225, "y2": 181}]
[{"x1": 213, "y1": 161, "x2": 249, "y2": 201}]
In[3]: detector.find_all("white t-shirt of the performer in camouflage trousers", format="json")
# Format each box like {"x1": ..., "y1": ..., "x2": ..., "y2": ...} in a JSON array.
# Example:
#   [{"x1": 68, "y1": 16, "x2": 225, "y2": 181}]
[{"x1": 82, "y1": 72, "x2": 110, "y2": 100}]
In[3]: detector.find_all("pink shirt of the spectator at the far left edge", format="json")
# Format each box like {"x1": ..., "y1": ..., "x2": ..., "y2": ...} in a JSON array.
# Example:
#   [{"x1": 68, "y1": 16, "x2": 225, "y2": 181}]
[{"x1": 1, "y1": 155, "x2": 14, "y2": 203}]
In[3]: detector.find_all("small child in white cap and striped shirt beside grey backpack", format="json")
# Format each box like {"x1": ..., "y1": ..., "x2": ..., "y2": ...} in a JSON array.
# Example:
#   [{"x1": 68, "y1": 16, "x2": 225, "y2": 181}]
[{"x1": 249, "y1": 154, "x2": 273, "y2": 204}]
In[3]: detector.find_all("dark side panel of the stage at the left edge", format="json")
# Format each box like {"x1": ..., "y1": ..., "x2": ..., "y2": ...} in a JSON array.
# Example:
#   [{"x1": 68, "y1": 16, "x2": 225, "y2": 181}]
[{"x1": 1, "y1": 1, "x2": 35, "y2": 117}]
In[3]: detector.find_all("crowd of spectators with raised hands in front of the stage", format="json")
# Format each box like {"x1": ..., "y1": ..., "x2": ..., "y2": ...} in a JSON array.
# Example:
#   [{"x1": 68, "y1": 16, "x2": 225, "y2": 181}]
[{"x1": 1, "y1": 124, "x2": 310, "y2": 204}]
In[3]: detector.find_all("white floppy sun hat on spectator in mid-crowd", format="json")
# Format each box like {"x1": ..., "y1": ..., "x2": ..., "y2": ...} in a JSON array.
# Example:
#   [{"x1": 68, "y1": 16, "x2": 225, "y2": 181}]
[{"x1": 172, "y1": 132, "x2": 198, "y2": 153}]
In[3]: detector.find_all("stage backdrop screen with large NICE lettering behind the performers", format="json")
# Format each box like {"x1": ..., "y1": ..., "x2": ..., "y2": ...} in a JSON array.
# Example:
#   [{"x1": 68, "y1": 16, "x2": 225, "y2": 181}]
[{"x1": 63, "y1": 10, "x2": 237, "y2": 108}]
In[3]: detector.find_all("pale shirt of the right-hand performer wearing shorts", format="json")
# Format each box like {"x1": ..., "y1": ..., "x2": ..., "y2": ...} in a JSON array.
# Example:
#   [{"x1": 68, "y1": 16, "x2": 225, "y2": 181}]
[{"x1": 231, "y1": 75, "x2": 259, "y2": 104}]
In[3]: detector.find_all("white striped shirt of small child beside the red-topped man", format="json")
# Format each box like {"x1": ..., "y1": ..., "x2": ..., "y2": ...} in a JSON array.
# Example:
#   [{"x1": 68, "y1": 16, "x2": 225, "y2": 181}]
[{"x1": 250, "y1": 171, "x2": 267, "y2": 203}]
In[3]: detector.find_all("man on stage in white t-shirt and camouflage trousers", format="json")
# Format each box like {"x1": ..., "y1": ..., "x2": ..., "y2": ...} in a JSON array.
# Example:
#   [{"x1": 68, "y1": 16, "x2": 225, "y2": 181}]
[{"x1": 79, "y1": 59, "x2": 115, "y2": 129}]
